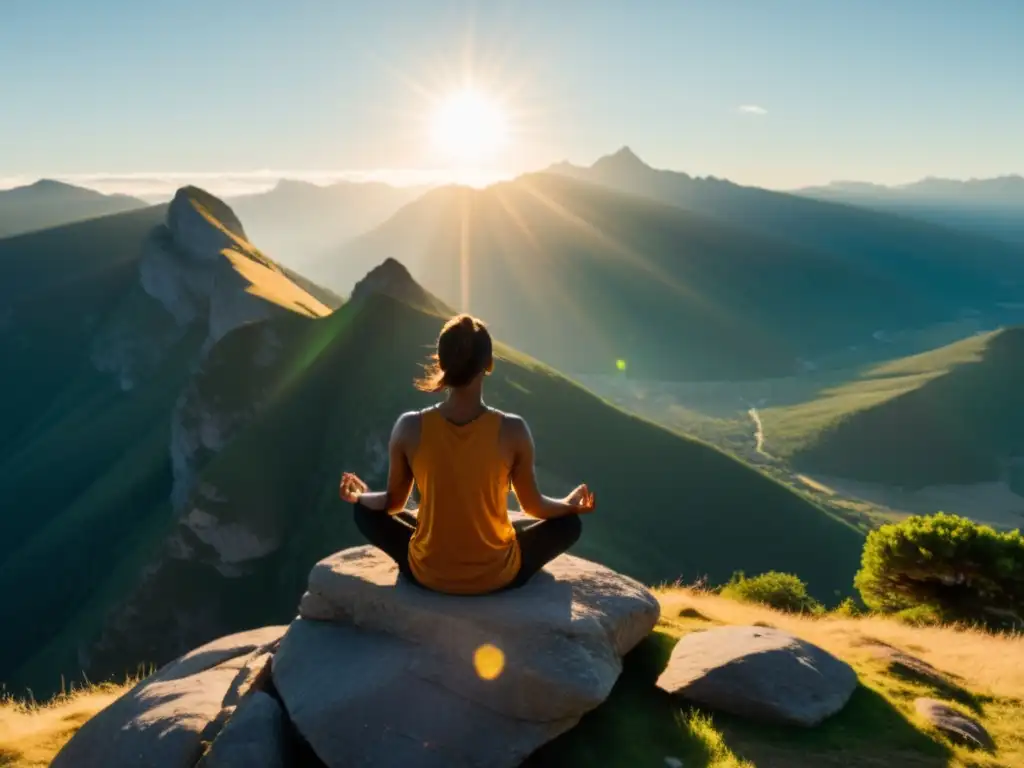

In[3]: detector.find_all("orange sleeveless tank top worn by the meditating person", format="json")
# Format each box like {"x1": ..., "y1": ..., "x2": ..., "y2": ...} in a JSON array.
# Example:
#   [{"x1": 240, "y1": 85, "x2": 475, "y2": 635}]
[{"x1": 409, "y1": 409, "x2": 520, "y2": 595}]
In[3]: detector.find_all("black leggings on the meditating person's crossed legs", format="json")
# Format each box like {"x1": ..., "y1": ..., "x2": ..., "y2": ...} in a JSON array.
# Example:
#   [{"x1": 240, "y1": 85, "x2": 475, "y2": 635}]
[{"x1": 355, "y1": 504, "x2": 583, "y2": 589}]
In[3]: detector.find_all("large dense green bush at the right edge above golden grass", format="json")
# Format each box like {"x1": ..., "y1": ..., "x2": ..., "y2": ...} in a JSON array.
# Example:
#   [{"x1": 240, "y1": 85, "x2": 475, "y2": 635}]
[{"x1": 854, "y1": 512, "x2": 1024, "y2": 626}]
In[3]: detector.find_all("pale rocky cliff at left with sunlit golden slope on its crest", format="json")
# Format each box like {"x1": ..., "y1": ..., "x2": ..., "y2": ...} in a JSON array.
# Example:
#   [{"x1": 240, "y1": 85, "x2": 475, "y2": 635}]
[{"x1": 91, "y1": 187, "x2": 327, "y2": 510}]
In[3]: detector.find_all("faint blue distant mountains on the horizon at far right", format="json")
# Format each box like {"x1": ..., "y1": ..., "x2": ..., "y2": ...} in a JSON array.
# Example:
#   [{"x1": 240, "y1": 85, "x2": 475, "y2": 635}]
[{"x1": 797, "y1": 175, "x2": 1024, "y2": 244}]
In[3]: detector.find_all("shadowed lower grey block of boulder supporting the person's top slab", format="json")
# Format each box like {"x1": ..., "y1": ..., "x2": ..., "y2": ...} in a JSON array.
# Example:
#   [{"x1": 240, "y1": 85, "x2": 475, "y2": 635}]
[{"x1": 273, "y1": 618, "x2": 579, "y2": 768}]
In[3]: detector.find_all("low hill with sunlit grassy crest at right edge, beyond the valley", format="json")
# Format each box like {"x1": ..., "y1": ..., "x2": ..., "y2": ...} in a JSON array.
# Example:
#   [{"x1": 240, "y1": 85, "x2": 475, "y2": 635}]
[{"x1": 761, "y1": 328, "x2": 1024, "y2": 487}]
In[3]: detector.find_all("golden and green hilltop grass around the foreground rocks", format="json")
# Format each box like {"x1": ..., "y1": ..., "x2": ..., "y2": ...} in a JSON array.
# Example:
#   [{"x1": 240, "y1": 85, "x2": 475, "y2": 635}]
[{"x1": 16, "y1": 588, "x2": 1024, "y2": 768}]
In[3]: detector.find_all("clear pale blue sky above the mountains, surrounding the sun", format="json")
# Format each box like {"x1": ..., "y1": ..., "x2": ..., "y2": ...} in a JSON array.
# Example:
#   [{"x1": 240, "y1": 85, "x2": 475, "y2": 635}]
[{"x1": 0, "y1": 0, "x2": 1024, "y2": 188}]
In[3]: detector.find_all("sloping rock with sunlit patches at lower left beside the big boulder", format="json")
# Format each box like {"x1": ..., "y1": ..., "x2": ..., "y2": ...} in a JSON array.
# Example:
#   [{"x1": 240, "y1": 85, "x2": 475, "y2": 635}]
[{"x1": 51, "y1": 627, "x2": 286, "y2": 768}]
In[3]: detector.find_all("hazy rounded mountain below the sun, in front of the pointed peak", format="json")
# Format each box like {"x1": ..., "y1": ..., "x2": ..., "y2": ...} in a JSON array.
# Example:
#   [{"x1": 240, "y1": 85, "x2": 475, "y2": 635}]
[{"x1": 314, "y1": 174, "x2": 954, "y2": 379}]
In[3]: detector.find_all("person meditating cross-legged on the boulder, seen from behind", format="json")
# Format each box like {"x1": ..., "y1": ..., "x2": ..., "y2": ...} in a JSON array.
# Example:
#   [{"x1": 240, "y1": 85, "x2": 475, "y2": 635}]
[{"x1": 340, "y1": 314, "x2": 595, "y2": 595}]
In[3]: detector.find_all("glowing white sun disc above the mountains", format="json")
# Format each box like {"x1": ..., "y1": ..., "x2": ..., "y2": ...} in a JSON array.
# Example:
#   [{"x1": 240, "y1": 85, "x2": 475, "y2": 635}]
[{"x1": 430, "y1": 89, "x2": 508, "y2": 163}]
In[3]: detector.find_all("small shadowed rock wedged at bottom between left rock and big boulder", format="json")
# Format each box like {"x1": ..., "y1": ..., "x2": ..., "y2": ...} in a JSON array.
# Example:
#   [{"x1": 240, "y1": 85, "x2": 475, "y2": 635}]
[{"x1": 199, "y1": 691, "x2": 288, "y2": 768}]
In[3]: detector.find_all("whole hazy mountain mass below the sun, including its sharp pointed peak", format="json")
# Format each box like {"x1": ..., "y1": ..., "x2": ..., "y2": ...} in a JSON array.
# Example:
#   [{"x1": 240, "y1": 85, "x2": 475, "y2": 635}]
[{"x1": 323, "y1": 148, "x2": 1024, "y2": 379}]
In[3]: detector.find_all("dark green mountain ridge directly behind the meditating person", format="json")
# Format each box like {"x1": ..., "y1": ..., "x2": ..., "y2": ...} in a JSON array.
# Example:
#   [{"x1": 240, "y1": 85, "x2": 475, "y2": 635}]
[{"x1": 49, "y1": 274, "x2": 861, "y2": 700}]
